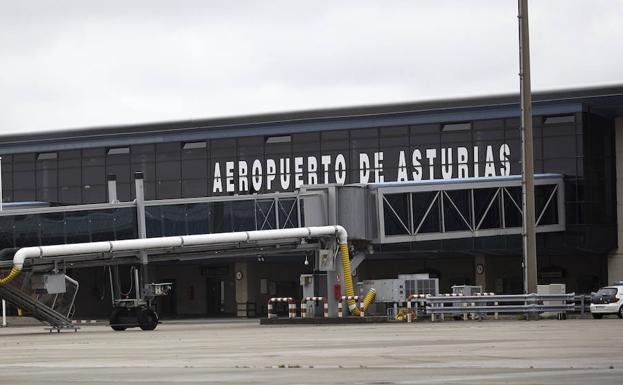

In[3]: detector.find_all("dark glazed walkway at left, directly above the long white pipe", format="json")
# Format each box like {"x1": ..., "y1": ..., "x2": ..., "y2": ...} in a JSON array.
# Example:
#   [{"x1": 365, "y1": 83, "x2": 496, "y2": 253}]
[{"x1": 0, "y1": 197, "x2": 303, "y2": 250}]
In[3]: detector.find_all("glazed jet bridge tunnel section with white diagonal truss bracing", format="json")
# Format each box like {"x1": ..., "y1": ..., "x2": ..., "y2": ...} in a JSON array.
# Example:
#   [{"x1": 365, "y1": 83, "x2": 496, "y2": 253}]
[{"x1": 377, "y1": 177, "x2": 565, "y2": 243}]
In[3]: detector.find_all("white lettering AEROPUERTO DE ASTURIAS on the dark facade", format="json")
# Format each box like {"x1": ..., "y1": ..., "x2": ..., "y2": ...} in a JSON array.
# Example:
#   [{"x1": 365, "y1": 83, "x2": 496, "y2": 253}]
[{"x1": 212, "y1": 143, "x2": 511, "y2": 193}]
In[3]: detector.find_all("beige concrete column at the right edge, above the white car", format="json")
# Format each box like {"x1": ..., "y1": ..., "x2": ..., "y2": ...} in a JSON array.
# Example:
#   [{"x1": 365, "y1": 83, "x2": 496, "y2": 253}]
[{"x1": 607, "y1": 117, "x2": 623, "y2": 285}]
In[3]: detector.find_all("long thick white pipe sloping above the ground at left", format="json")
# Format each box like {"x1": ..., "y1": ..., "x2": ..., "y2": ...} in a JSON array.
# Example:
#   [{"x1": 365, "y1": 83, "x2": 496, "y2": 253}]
[{"x1": 13, "y1": 226, "x2": 348, "y2": 270}]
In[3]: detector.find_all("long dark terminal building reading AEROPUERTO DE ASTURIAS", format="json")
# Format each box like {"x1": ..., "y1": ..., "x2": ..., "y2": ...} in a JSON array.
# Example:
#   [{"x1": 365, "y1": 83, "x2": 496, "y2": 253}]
[{"x1": 0, "y1": 86, "x2": 623, "y2": 317}]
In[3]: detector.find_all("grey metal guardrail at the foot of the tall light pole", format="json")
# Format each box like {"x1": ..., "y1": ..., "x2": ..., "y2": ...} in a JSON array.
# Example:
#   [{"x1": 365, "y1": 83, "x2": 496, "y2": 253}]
[{"x1": 426, "y1": 293, "x2": 575, "y2": 321}]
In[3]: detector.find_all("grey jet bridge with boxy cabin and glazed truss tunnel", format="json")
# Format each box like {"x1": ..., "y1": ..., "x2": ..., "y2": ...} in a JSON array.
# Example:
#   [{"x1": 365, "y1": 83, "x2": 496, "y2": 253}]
[{"x1": 299, "y1": 174, "x2": 565, "y2": 244}]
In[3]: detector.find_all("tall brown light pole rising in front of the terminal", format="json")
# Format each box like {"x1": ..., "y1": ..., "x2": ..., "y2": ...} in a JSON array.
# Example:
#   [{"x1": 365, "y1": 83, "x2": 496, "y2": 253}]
[{"x1": 518, "y1": 0, "x2": 537, "y2": 294}]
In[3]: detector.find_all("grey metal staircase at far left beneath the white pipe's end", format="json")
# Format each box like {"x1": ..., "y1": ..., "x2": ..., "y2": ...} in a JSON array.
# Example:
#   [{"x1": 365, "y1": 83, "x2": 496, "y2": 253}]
[{"x1": 0, "y1": 273, "x2": 78, "y2": 331}]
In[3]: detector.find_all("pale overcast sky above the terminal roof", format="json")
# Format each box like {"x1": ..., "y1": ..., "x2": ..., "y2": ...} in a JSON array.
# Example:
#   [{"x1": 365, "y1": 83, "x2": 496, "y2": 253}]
[{"x1": 0, "y1": 0, "x2": 623, "y2": 134}]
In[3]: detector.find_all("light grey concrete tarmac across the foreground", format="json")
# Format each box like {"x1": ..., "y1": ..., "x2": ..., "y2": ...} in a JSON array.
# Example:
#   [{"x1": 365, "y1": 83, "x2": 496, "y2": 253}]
[{"x1": 0, "y1": 318, "x2": 623, "y2": 385}]
